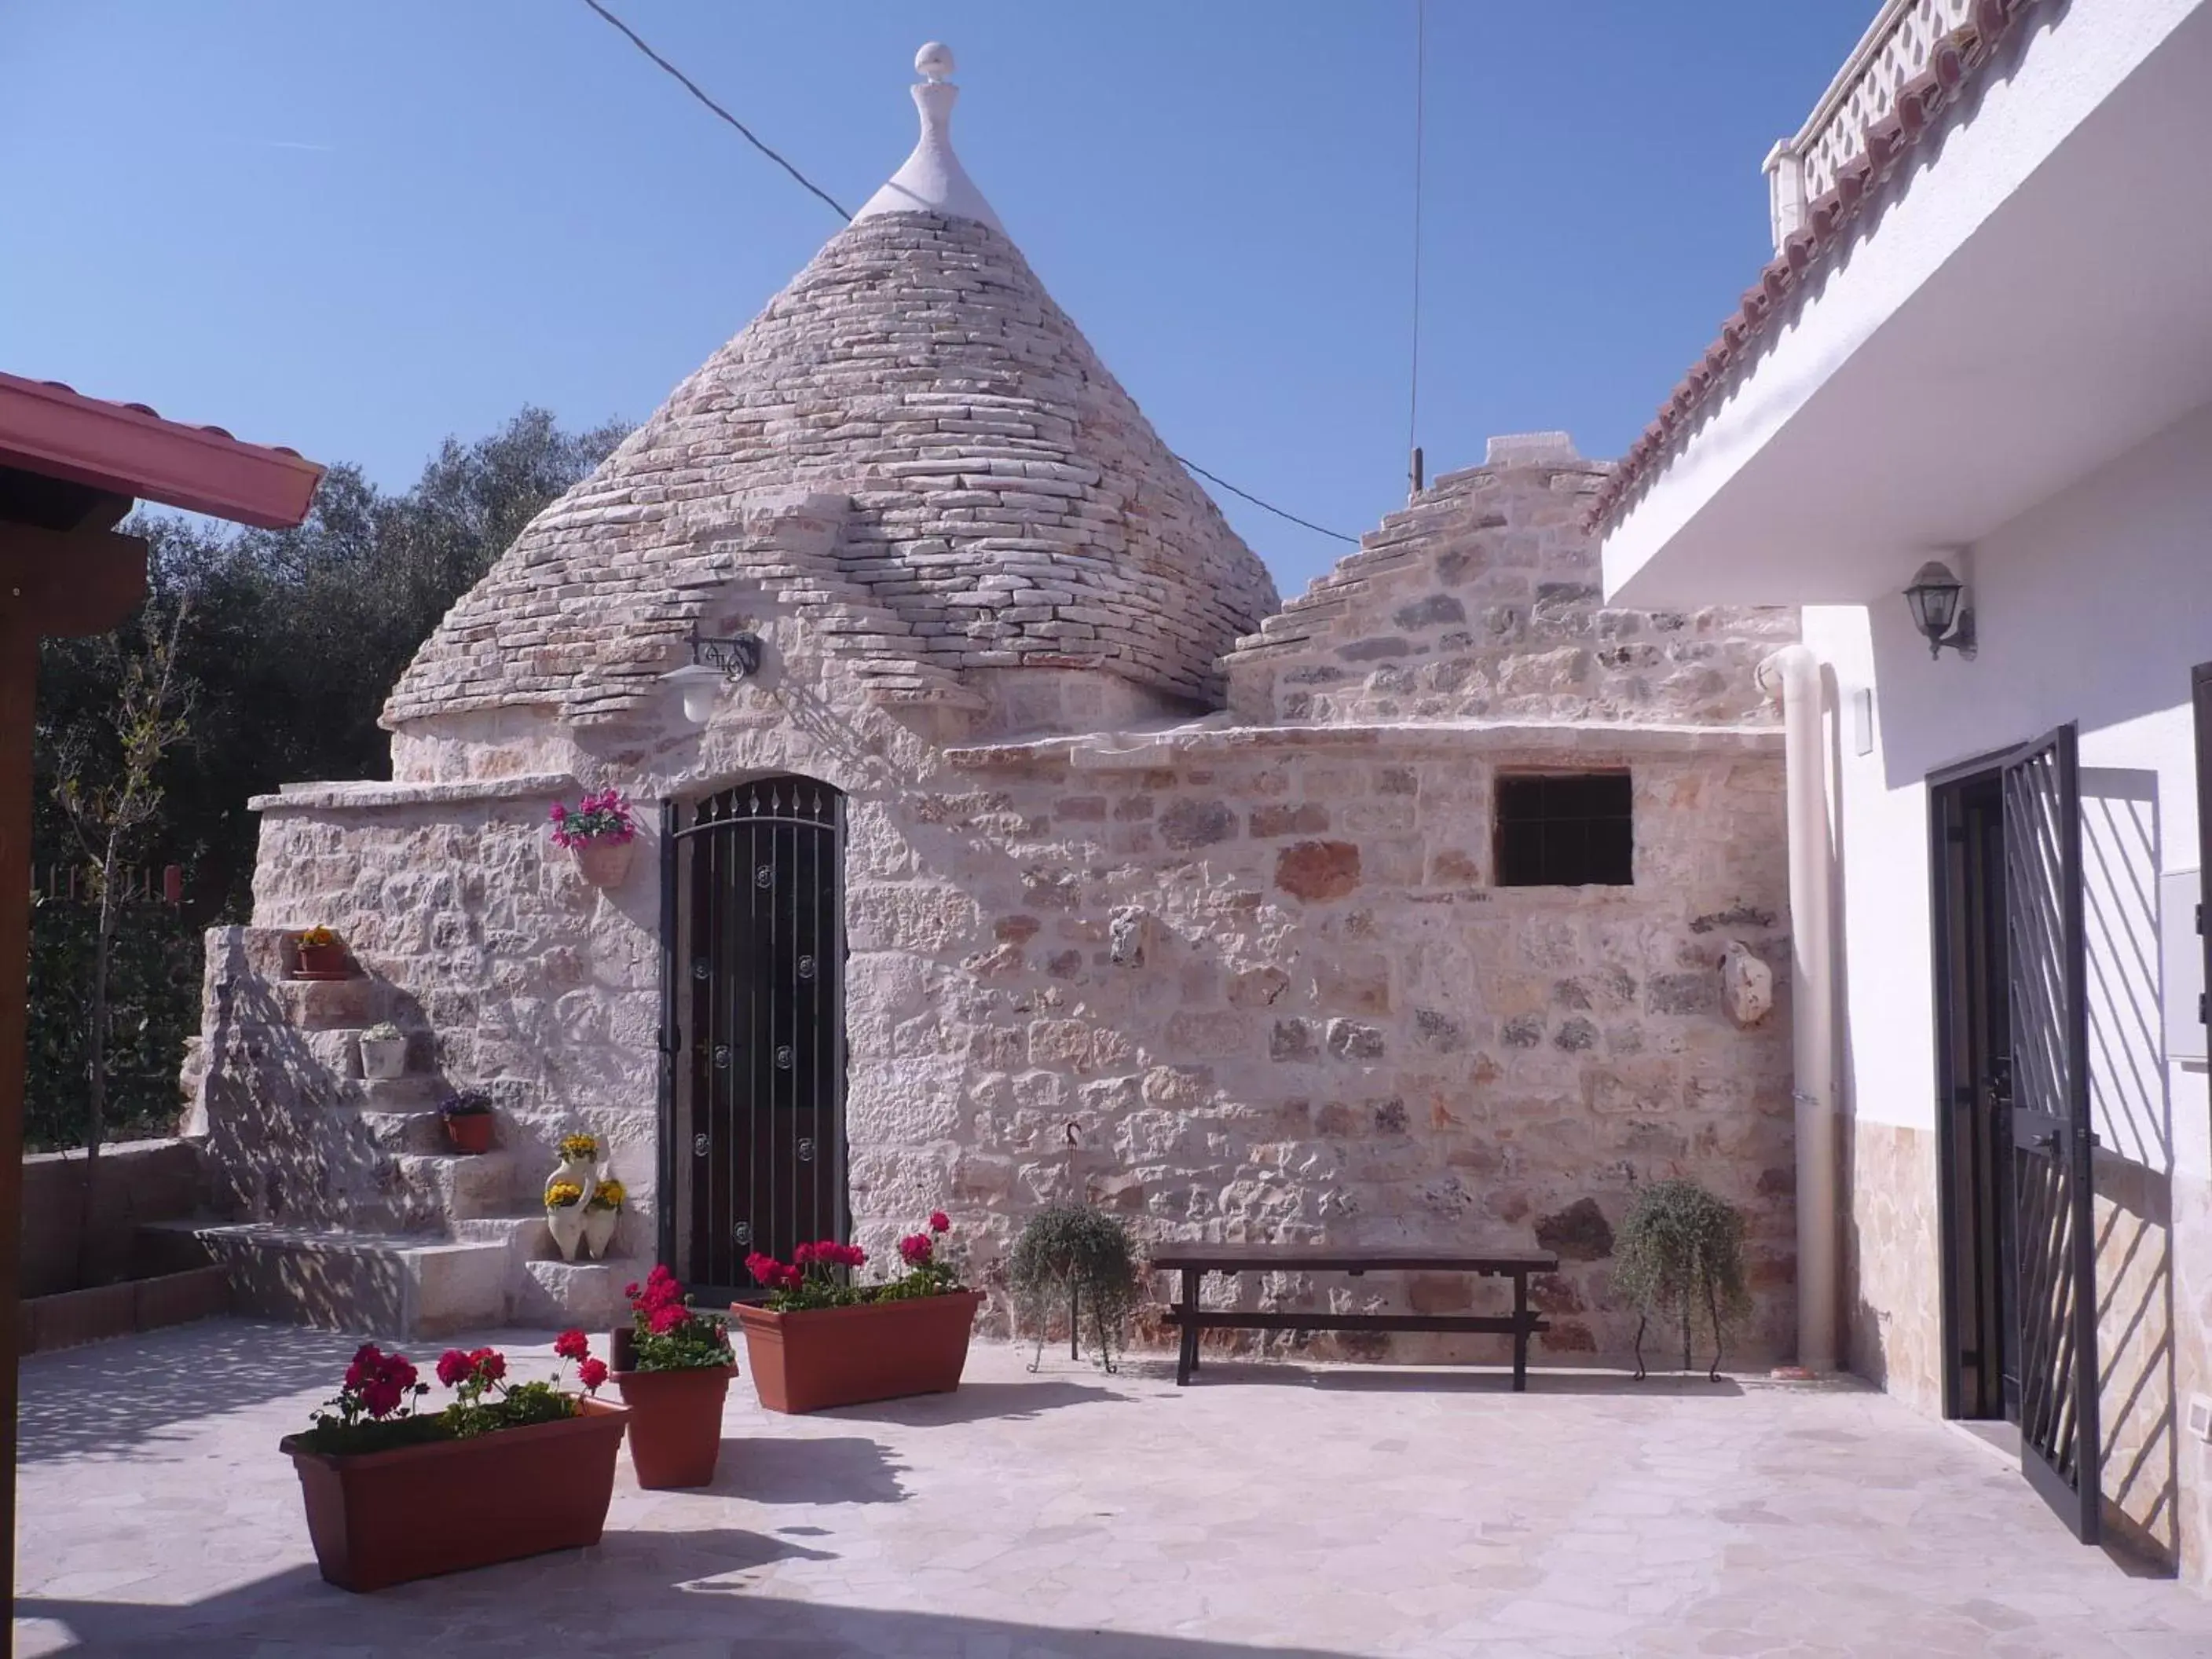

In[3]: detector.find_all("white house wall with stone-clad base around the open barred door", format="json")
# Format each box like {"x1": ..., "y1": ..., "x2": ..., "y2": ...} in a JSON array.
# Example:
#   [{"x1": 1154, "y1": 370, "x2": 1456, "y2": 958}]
[{"x1": 1805, "y1": 396, "x2": 2212, "y2": 1580}]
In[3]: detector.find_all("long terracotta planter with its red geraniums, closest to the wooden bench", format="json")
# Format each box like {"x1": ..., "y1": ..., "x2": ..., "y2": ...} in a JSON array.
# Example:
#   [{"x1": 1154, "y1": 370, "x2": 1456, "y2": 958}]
[{"x1": 730, "y1": 1210, "x2": 982, "y2": 1412}]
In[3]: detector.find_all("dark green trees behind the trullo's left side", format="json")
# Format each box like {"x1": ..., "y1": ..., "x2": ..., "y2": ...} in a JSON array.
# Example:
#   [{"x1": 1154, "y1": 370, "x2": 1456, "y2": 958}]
[{"x1": 29, "y1": 409, "x2": 624, "y2": 1146}]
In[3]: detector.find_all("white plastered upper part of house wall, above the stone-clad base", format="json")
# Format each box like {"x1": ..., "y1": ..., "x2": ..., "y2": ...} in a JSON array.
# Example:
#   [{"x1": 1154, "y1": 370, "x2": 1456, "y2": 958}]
[{"x1": 1805, "y1": 394, "x2": 2212, "y2": 1177}]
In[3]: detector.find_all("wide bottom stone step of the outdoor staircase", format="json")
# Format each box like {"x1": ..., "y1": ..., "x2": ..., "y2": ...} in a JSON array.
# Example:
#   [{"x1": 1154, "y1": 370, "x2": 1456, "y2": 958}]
[{"x1": 195, "y1": 1221, "x2": 509, "y2": 1340}]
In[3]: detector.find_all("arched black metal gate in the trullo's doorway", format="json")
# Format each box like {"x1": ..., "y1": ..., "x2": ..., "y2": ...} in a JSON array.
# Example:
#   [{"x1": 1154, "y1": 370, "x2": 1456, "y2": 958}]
[{"x1": 661, "y1": 776, "x2": 848, "y2": 1301}]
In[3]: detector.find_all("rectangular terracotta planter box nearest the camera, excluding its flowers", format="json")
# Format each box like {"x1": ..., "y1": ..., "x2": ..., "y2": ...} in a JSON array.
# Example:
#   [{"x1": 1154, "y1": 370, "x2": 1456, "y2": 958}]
[{"x1": 279, "y1": 1401, "x2": 631, "y2": 1591}]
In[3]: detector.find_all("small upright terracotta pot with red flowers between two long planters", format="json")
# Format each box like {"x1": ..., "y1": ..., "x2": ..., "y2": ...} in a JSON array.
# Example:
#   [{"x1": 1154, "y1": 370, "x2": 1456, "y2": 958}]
[{"x1": 615, "y1": 1268, "x2": 737, "y2": 1491}]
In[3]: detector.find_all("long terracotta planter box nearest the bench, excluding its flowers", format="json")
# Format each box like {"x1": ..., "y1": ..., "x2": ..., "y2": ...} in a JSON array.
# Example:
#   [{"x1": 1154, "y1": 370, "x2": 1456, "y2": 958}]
[{"x1": 730, "y1": 1290, "x2": 982, "y2": 1412}]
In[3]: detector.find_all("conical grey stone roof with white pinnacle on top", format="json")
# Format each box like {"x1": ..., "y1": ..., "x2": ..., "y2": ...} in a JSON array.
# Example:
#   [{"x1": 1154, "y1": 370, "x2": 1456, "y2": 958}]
[{"x1": 385, "y1": 49, "x2": 1276, "y2": 727}]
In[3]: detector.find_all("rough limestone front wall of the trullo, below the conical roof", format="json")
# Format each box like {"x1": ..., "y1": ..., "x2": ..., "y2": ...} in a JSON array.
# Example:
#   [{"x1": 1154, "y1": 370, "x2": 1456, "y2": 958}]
[{"x1": 199, "y1": 438, "x2": 1794, "y2": 1363}]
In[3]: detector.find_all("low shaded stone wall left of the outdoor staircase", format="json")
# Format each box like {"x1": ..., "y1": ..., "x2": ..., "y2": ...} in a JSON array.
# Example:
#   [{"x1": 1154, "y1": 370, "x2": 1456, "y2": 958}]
[{"x1": 22, "y1": 1141, "x2": 206, "y2": 1298}]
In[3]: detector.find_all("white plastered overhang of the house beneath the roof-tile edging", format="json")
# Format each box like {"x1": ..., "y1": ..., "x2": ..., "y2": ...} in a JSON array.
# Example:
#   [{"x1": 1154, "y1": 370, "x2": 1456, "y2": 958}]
[{"x1": 1604, "y1": 0, "x2": 2212, "y2": 606}]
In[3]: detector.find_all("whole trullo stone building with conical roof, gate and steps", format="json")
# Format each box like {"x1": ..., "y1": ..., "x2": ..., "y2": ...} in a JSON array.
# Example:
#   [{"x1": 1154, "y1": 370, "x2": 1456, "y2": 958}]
[{"x1": 188, "y1": 45, "x2": 1794, "y2": 1358}]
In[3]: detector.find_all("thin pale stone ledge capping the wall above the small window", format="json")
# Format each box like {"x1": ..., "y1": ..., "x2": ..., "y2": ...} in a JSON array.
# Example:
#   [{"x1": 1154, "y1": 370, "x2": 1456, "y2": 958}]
[{"x1": 944, "y1": 721, "x2": 1783, "y2": 770}]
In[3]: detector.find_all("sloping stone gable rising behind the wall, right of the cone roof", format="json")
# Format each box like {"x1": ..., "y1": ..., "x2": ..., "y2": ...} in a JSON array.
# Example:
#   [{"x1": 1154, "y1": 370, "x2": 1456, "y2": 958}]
[{"x1": 1228, "y1": 456, "x2": 1796, "y2": 738}]
